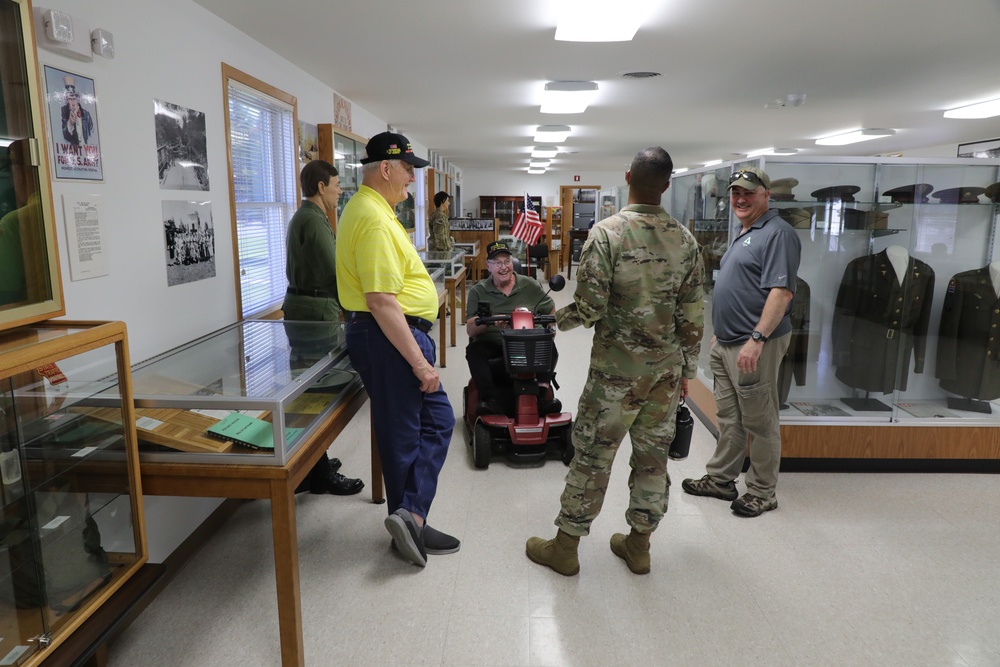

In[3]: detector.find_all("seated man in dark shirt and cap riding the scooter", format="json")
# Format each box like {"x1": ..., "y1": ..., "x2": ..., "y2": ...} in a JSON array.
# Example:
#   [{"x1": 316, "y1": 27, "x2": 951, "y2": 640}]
[{"x1": 465, "y1": 241, "x2": 562, "y2": 415}]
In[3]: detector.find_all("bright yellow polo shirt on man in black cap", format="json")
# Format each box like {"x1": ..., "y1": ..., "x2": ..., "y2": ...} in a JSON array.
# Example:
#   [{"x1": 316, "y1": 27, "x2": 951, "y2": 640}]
[{"x1": 337, "y1": 185, "x2": 438, "y2": 321}]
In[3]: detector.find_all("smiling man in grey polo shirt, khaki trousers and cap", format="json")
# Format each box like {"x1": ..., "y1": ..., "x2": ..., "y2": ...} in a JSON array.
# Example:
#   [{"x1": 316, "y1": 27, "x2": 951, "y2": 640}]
[{"x1": 681, "y1": 167, "x2": 802, "y2": 516}]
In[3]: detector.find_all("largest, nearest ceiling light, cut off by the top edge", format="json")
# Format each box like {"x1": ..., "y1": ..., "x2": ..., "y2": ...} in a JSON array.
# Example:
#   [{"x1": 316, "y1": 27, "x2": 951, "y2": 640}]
[{"x1": 556, "y1": 0, "x2": 656, "y2": 42}]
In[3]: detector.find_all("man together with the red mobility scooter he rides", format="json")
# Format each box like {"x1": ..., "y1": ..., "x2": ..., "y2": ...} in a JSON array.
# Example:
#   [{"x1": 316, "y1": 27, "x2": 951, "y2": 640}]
[{"x1": 465, "y1": 241, "x2": 572, "y2": 468}]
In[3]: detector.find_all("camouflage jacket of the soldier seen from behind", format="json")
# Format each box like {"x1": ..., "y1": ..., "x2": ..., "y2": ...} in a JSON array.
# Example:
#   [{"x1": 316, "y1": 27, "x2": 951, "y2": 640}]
[{"x1": 556, "y1": 204, "x2": 705, "y2": 378}]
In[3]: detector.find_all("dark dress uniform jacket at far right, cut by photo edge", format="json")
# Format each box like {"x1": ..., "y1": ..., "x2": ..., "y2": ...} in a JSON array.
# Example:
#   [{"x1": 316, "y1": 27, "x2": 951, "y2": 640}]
[{"x1": 935, "y1": 266, "x2": 1000, "y2": 401}]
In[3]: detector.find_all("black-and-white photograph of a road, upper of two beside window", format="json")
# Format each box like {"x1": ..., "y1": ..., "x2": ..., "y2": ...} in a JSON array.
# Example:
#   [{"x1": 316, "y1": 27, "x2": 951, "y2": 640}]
[{"x1": 153, "y1": 100, "x2": 208, "y2": 190}]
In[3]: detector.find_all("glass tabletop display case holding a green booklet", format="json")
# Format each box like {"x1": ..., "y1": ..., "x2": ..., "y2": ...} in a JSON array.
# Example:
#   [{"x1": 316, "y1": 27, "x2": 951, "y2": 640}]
[{"x1": 120, "y1": 320, "x2": 361, "y2": 466}]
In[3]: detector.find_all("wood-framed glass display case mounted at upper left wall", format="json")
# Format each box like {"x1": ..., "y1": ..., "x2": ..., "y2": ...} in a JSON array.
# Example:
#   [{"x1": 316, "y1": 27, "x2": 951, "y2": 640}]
[{"x1": 0, "y1": 0, "x2": 66, "y2": 331}]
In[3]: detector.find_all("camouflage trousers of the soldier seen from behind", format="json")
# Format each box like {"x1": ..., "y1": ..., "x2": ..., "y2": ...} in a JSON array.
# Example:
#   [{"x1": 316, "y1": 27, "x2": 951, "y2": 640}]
[{"x1": 555, "y1": 363, "x2": 681, "y2": 536}]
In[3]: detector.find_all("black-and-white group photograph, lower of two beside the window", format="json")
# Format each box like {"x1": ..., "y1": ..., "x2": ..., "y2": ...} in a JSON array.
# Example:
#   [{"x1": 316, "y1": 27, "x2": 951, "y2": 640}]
[{"x1": 163, "y1": 201, "x2": 215, "y2": 287}]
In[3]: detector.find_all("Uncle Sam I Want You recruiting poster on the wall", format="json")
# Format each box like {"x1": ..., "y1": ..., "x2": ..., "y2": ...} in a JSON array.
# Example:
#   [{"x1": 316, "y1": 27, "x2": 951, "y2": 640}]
[{"x1": 45, "y1": 65, "x2": 104, "y2": 181}]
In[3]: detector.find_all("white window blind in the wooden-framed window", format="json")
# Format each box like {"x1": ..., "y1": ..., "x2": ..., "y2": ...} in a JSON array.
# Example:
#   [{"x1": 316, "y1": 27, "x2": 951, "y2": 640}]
[{"x1": 228, "y1": 79, "x2": 298, "y2": 318}]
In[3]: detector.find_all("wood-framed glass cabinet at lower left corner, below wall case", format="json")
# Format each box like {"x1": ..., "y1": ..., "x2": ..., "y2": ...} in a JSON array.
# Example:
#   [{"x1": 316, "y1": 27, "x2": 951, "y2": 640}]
[{"x1": 0, "y1": 322, "x2": 146, "y2": 665}]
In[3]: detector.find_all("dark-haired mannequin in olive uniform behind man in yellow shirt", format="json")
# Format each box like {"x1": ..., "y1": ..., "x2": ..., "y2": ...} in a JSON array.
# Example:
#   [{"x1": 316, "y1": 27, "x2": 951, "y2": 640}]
[{"x1": 281, "y1": 160, "x2": 365, "y2": 496}]
